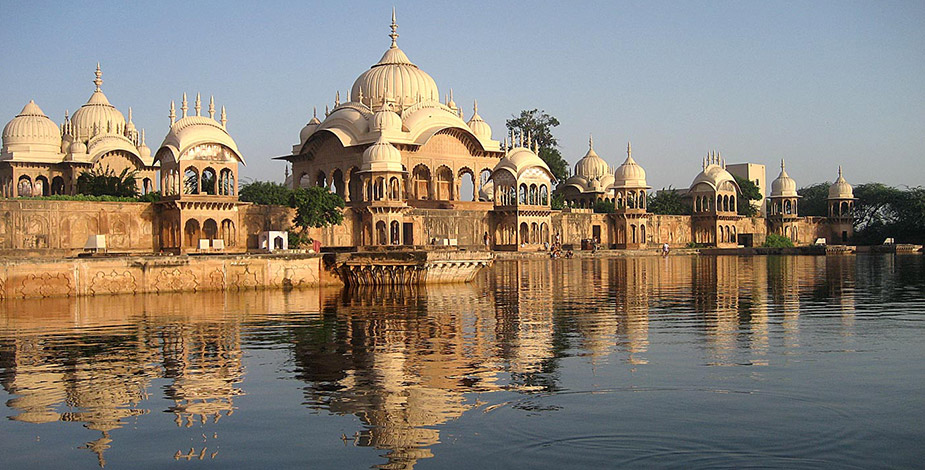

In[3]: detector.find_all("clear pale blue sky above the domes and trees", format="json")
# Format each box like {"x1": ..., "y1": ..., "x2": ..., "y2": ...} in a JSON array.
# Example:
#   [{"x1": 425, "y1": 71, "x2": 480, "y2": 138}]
[{"x1": 0, "y1": 0, "x2": 925, "y2": 188}]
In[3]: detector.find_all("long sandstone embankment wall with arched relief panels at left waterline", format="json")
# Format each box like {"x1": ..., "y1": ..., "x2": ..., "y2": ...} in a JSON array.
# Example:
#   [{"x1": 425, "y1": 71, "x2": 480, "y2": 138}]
[{"x1": 0, "y1": 254, "x2": 341, "y2": 300}]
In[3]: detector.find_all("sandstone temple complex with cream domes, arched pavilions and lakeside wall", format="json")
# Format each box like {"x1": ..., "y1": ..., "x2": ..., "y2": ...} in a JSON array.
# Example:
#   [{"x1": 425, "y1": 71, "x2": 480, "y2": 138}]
[{"x1": 0, "y1": 12, "x2": 855, "y2": 255}]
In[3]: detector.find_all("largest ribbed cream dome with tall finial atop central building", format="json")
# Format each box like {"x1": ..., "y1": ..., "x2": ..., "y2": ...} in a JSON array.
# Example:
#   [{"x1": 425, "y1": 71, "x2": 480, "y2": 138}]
[{"x1": 350, "y1": 11, "x2": 440, "y2": 109}]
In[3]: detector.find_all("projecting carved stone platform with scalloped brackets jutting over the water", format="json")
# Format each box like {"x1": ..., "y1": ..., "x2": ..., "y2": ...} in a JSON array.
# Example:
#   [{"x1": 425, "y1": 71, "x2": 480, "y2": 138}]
[{"x1": 326, "y1": 251, "x2": 493, "y2": 286}]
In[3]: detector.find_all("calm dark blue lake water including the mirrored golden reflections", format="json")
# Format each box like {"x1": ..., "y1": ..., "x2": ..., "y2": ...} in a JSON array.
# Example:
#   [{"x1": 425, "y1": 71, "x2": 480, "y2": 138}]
[{"x1": 0, "y1": 255, "x2": 925, "y2": 469}]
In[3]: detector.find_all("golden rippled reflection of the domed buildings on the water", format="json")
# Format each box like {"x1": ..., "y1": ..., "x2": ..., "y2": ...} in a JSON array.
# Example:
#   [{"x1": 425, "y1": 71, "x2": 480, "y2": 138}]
[{"x1": 0, "y1": 256, "x2": 921, "y2": 469}]
